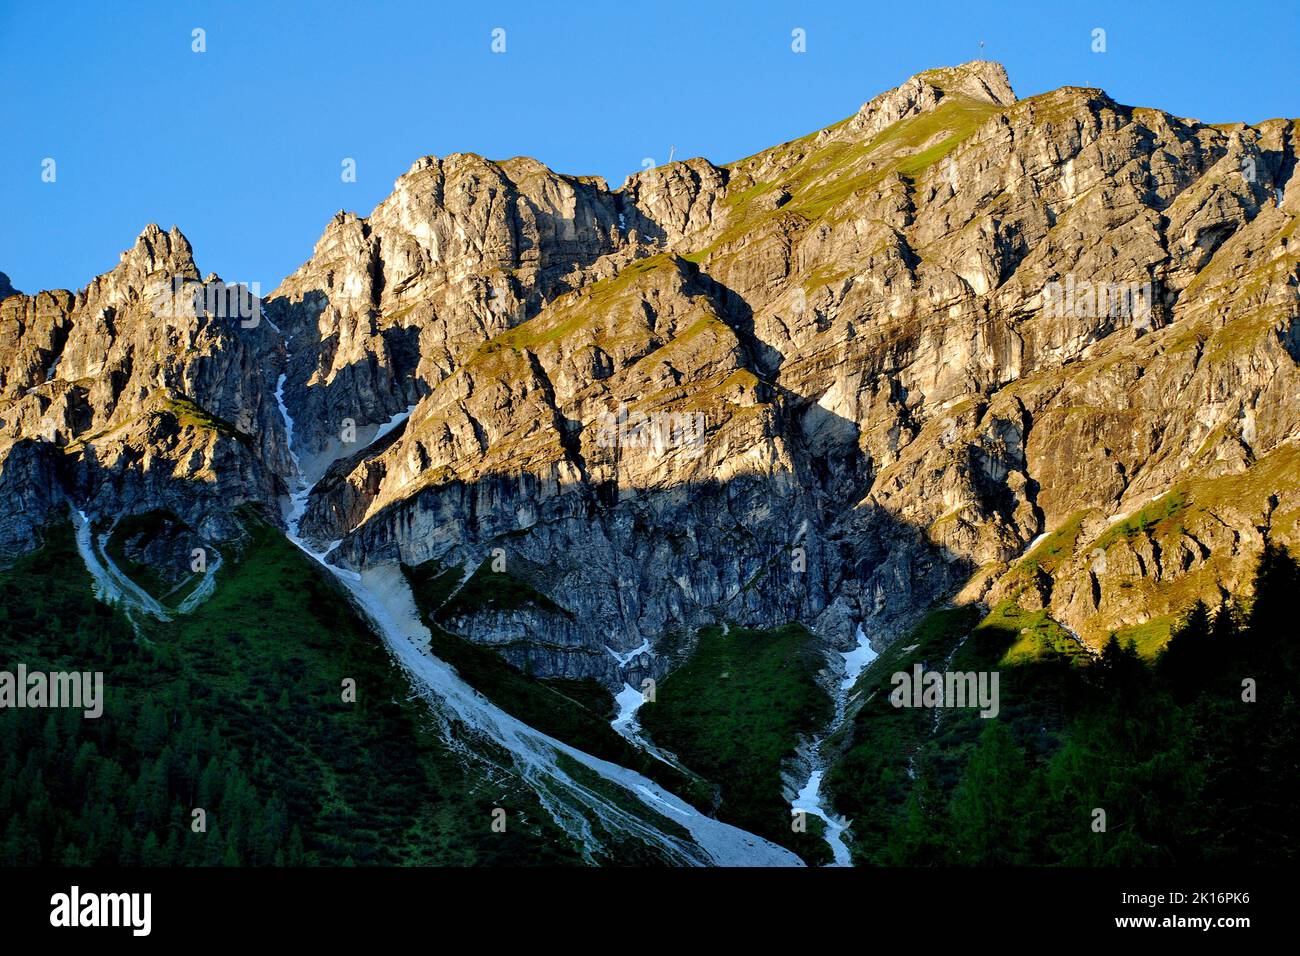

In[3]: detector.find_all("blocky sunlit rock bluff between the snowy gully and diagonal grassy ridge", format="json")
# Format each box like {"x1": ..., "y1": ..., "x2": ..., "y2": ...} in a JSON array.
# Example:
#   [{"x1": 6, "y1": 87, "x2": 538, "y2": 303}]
[{"x1": 268, "y1": 155, "x2": 629, "y2": 481}]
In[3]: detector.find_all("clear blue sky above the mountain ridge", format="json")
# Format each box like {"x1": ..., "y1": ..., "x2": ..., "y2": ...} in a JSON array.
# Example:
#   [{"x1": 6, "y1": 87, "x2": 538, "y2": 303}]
[{"x1": 0, "y1": 0, "x2": 1300, "y2": 293}]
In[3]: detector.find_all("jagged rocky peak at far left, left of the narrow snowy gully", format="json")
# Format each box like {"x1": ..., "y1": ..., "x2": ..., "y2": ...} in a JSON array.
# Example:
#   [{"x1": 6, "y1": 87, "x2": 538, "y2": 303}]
[{"x1": 0, "y1": 226, "x2": 291, "y2": 555}]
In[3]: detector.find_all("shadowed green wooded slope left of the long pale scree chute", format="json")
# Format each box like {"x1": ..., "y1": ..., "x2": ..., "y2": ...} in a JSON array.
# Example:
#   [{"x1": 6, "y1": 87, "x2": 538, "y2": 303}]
[{"x1": 0, "y1": 522, "x2": 576, "y2": 865}]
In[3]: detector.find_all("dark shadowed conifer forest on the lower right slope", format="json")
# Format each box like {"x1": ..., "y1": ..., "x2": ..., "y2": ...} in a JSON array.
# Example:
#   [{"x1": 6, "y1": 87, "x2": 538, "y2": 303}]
[{"x1": 831, "y1": 545, "x2": 1300, "y2": 866}]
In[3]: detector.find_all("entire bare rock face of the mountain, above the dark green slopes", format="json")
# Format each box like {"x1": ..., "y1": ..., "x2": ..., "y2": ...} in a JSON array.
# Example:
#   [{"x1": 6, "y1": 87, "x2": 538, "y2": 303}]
[{"x1": 0, "y1": 62, "x2": 1300, "y2": 687}]
